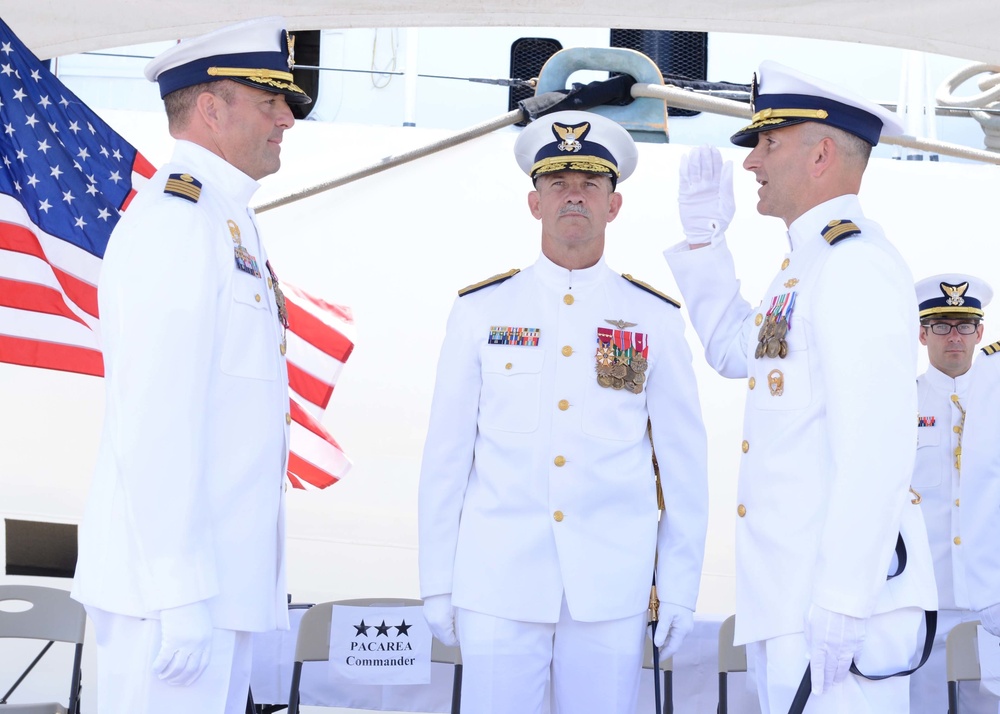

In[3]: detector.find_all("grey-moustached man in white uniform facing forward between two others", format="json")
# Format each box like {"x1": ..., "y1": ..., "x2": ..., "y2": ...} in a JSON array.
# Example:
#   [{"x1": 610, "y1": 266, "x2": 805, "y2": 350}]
[{"x1": 419, "y1": 112, "x2": 708, "y2": 714}]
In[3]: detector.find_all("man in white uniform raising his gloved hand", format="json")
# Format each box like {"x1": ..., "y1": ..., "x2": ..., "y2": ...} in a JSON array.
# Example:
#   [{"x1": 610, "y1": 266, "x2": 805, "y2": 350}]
[{"x1": 665, "y1": 62, "x2": 937, "y2": 714}]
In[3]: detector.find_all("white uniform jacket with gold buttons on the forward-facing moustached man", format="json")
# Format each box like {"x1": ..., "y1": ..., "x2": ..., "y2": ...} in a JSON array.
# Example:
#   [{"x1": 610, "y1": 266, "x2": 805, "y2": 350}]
[{"x1": 419, "y1": 256, "x2": 708, "y2": 622}]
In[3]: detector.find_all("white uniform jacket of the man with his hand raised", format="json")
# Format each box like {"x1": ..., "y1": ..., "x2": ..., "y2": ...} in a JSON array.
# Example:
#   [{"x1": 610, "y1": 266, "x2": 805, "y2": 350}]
[{"x1": 665, "y1": 195, "x2": 937, "y2": 644}]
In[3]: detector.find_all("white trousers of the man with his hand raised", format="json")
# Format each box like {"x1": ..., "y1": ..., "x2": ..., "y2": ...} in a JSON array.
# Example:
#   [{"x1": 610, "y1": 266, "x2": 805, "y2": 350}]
[{"x1": 747, "y1": 607, "x2": 920, "y2": 714}]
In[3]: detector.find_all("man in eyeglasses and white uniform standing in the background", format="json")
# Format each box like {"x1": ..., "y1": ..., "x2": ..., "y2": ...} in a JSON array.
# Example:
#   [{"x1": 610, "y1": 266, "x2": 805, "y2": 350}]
[{"x1": 910, "y1": 273, "x2": 997, "y2": 714}]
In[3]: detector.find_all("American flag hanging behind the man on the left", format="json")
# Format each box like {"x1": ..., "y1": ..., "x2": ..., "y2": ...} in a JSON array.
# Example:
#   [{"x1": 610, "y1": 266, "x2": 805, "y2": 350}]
[{"x1": 0, "y1": 20, "x2": 354, "y2": 488}]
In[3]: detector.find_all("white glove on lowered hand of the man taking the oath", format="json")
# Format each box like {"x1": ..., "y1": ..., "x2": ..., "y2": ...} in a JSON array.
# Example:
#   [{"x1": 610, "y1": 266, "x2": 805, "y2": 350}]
[{"x1": 805, "y1": 605, "x2": 865, "y2": 694}]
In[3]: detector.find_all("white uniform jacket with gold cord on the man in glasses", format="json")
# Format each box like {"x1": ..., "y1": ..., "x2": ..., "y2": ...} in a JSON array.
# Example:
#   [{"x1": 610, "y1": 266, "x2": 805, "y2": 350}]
[{"x1": 912, "y1": 366, "x2": 972, "y2": 610}]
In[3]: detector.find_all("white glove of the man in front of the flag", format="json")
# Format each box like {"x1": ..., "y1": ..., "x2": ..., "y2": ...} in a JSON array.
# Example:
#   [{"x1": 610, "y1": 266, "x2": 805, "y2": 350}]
[{"x1": 153, "y1": 601, "x2": 212, "y2": 687}]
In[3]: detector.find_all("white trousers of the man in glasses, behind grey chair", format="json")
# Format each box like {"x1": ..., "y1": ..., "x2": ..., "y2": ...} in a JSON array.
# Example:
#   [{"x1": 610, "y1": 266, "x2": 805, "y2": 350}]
[{"x1": 910, "y1": 610, "x2": 1000, "y2": 714}]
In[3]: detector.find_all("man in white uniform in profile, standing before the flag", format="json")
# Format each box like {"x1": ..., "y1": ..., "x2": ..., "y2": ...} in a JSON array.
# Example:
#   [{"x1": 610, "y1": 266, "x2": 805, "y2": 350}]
[{"x1": 73, "y1": 18, "x2": 309, "y2": 714}]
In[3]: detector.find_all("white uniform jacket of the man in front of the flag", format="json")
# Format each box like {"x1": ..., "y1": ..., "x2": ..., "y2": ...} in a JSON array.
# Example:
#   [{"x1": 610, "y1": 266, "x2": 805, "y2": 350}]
[{"x1": 73, "y1": 141, "x2": 289, "y2": 631}]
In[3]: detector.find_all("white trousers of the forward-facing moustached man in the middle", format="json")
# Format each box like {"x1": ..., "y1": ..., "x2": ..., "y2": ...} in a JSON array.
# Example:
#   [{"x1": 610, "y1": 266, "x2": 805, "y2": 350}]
[{"x1": 456, "y1": 598, "x2": 646, "y2": 714}]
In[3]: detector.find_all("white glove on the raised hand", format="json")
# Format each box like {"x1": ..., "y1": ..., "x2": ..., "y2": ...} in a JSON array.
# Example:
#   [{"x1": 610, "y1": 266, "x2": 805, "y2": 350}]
[{"x1": 677, "y1": 146, "x2": 736, "y2": 244}]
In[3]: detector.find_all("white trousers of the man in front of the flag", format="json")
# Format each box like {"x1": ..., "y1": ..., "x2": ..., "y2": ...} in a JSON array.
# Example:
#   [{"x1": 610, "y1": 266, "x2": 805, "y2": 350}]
[{"x1": 87, "y1": 607, "x2": 253, "y2": 714}]
